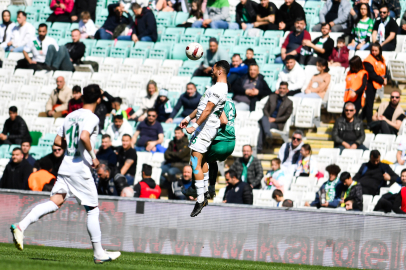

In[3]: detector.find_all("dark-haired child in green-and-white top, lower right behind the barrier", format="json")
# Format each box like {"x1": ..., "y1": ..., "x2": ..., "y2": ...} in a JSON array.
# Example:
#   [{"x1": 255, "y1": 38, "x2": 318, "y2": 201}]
[{"x1": 305, "y1": 164, "x2": 343, "y2": 208}]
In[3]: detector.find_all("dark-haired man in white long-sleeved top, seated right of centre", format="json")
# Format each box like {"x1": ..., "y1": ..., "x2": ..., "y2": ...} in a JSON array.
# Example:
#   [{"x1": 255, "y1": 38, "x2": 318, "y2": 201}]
[{"x1": 276, "y1": 55, "x2": 306, "y2": 96}]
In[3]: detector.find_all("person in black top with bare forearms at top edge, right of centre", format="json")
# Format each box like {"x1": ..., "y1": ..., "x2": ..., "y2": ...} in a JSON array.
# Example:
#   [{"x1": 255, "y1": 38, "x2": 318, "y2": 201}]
[{"x1": 254, "y1": 0, "x2": 279, "y2": 31}]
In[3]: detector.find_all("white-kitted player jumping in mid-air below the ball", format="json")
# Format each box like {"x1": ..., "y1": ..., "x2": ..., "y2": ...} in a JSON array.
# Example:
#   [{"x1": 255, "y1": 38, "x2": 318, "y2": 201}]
[{"x1": 180, "y1": 60, "x2": 230, "y2": 217}]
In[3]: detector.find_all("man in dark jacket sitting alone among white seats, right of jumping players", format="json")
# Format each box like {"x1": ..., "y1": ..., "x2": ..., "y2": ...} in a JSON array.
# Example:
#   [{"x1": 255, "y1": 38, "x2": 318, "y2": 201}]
[{"x1": 257, "y1": 82, "x2": 293, "y2": 152}]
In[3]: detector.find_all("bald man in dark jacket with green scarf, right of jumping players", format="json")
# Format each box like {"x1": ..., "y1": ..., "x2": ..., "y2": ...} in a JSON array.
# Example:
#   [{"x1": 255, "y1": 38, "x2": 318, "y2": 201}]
[{"x1": 230, "y1": 144, "x2": 264, "y2": 189}]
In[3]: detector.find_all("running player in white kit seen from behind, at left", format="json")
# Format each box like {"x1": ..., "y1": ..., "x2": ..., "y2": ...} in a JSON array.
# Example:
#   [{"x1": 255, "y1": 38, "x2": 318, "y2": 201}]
[{"x1": 11, "y1": 84, "x2": 121, "y2": 264}]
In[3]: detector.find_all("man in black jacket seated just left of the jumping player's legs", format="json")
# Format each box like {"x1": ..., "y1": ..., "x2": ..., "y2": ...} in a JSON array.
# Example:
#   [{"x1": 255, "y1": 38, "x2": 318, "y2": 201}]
[{"x1": 160, "y1": 126, "x2": 190, "y2": 187}]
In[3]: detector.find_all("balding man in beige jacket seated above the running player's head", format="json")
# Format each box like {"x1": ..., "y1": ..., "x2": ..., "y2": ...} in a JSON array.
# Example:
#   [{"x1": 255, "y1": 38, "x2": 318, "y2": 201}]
[{"x1": 38, "y1": 76, "x2": 72, "y2": 118}]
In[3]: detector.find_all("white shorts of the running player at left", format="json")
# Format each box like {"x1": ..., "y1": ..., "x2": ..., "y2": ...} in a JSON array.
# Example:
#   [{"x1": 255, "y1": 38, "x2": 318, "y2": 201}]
[{"x1": 51, "y1": 175, "x2": 99, "y2": 207}]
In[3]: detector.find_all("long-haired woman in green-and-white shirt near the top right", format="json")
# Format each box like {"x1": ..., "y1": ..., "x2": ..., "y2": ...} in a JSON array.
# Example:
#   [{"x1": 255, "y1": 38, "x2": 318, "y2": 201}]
[{"x1": 348, "y1": 3, "x2": 374, "y2": 51}]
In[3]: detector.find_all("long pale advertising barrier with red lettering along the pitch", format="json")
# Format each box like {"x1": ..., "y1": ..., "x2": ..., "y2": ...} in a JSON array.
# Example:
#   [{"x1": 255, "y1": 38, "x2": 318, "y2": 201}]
[{"x1": 0, "y1": 189, "x2": 406, "y2": 269}]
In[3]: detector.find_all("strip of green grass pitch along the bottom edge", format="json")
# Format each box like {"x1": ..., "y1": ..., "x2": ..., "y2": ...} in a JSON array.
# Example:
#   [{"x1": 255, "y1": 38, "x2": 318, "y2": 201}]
[{"x1": 0, "y1": 243, "x2": 358, "y2": 270}]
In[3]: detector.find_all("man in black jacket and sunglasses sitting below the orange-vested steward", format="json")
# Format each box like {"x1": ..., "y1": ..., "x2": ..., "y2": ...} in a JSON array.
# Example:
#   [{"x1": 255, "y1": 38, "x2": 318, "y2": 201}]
[{"x1": 332, "y1": 102, "x2": 367, "y2": 153}]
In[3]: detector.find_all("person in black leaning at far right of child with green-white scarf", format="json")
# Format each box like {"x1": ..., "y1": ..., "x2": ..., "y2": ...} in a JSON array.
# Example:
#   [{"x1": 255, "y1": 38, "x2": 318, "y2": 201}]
[{"x1": 340, "y1": 172, "x2": 364, "y2": 211}]
